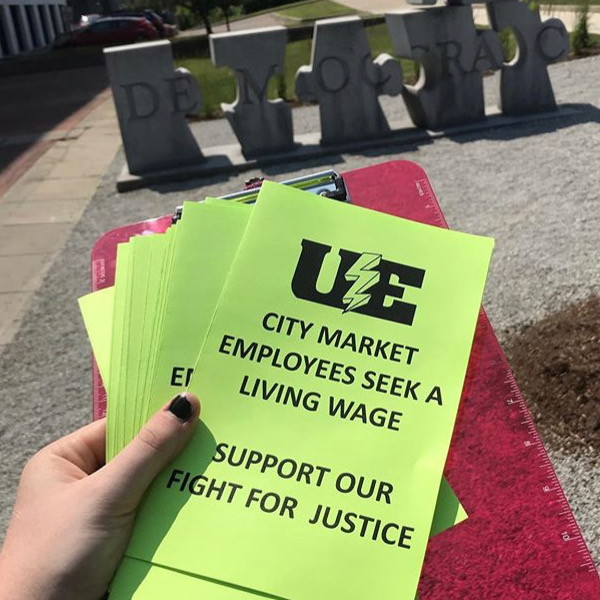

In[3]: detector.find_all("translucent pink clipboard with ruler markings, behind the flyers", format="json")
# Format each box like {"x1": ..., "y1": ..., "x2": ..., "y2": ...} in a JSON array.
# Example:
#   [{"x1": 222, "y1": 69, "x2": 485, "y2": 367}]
[{"x1": 92, "y1": 161, "x2": 600, "y2": 600}]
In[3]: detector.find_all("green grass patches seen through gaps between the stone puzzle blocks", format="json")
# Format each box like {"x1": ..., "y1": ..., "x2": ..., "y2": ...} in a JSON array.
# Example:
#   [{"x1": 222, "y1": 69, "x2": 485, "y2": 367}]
[{"x1": 176, "y1": 23, "x2": 418, "y2": 118}]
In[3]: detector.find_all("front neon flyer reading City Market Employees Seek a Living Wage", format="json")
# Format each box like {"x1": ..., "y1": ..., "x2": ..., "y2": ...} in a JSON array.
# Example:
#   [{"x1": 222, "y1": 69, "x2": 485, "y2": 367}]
[{"x1": 127, "y1": 182, "x2": 493, "y2": 600}]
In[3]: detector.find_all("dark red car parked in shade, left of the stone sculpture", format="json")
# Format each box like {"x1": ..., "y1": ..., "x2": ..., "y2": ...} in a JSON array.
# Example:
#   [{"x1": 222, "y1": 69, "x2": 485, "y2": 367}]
[{"x1": 54, "y1": 17, "x2": 160, "y2": 48}]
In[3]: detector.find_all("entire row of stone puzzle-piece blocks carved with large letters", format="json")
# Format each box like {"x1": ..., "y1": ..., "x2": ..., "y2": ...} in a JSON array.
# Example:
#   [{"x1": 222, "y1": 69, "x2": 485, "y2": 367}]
[{"x1": 105, "y1": 14, "x2": 569, "y2": 189}]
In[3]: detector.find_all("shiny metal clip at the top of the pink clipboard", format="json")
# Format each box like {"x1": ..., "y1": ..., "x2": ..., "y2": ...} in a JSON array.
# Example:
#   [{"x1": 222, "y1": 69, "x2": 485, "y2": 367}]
[{"x1": 172, "y1": 169, "x2": 350, "y2": 223}]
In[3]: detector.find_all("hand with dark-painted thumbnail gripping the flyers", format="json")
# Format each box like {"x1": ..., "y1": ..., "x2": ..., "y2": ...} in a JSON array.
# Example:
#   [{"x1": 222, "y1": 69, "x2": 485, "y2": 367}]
[{"x1": 0, "y1": 394, "x2": 200, "y2": 600}]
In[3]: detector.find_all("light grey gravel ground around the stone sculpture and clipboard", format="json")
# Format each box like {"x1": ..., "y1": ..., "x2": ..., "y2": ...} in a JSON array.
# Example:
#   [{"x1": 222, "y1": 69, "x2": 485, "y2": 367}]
[{"x1": 0, "y1": 52, "x2": 600, "y2": 564}]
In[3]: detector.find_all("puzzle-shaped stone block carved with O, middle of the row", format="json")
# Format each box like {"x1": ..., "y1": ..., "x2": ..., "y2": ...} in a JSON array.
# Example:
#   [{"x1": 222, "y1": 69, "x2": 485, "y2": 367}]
[{"x1": 296, "y1": 17, "x2": 402, "y2": 145}]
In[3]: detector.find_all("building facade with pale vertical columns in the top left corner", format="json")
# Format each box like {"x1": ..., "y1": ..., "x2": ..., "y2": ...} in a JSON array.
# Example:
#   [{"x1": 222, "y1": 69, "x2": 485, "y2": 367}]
[{"x1": 0, "y1": 0, "x2": 67, "y2": 58}]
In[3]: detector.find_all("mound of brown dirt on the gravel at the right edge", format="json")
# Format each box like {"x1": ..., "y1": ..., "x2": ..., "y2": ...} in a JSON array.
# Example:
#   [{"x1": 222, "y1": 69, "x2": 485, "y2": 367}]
[{"x1": 505, "y1": 296, "x2": 600, "y2": 452}]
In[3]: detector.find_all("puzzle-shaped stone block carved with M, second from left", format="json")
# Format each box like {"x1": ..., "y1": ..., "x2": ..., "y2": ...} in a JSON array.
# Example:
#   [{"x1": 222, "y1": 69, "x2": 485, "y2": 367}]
[{"x1": 209, "y1": 27, "x2": 294, "y2": 158}]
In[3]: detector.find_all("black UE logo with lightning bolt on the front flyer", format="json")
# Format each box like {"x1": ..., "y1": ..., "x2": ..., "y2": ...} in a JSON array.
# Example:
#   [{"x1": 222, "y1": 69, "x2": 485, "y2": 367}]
[{"x1": 292, "y1": 240, "x2": 425, "y2": 325}]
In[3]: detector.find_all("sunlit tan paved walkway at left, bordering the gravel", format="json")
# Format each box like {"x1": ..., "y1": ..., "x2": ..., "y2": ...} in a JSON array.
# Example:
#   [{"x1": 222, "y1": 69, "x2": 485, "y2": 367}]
[{"x1": 0, "y1": 93, "x2": 121, "y2": 352}]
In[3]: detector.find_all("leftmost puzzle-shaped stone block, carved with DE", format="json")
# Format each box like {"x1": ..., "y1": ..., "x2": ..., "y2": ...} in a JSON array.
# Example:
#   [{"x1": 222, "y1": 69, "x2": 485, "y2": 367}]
[{"x1": 104, "y1": 40, "x2": 204, "y2": 175}]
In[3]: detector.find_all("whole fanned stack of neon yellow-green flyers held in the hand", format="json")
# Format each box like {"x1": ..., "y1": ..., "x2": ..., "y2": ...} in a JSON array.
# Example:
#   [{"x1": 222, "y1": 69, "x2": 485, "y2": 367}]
[{"x1": 81, "y1": 182, "x2": 493, "y2": 600}]
